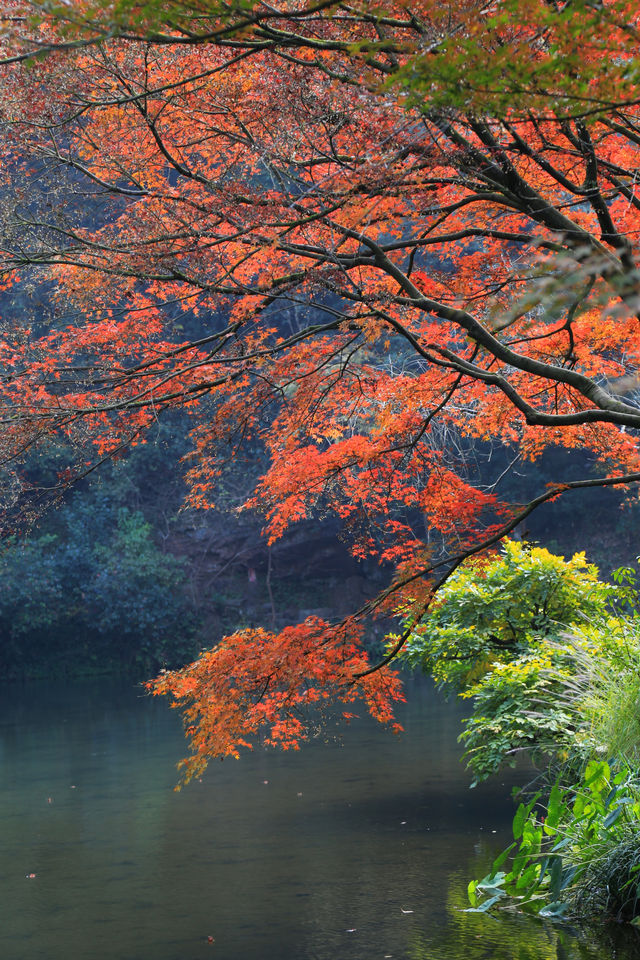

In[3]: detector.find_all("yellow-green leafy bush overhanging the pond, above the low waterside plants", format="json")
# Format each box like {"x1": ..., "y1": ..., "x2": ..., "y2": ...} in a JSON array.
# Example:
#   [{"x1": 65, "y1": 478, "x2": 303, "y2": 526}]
[{"x1": 404, "y1": 541, "x2": 616, "y2": 783}]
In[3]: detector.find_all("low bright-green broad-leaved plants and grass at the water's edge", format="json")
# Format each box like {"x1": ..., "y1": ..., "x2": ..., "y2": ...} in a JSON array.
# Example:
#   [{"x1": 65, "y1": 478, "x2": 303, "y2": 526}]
[{"x1": 468, "y1": 760, "x2": 640, "y2": 923}]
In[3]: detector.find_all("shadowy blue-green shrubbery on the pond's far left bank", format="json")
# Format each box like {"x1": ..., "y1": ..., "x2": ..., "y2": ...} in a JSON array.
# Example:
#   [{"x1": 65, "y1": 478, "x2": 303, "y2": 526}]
[{"x1": 0, "y1": 495, "x2": 195, "y2": 677}]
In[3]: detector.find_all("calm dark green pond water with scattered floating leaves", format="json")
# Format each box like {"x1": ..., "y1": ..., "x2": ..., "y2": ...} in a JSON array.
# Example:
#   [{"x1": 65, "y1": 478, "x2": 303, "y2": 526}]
[{"x1": 0, "y1": 680, "x2": 640, "y2": 960}]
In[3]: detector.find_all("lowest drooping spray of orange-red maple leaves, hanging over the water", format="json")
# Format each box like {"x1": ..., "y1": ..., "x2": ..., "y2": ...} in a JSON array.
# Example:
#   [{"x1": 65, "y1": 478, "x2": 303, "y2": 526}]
[{"x1": 147, "y1": 617, "x2": 404, "y2": 782}]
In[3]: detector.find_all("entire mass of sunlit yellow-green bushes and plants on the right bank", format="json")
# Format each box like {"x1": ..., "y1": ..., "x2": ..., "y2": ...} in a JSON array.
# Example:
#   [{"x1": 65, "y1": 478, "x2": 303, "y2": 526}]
[{"x1": 406, "y1": 542, "x2": 640, "y2": 922}]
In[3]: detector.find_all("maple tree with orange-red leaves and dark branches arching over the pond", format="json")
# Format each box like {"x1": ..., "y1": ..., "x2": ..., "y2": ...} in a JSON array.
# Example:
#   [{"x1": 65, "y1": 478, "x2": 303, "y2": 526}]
[{"x1": 0, "y1": 0, "x2": 640, "y2": 774}]
